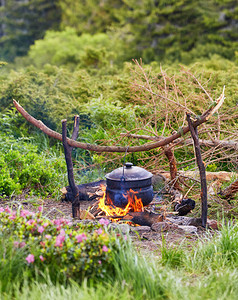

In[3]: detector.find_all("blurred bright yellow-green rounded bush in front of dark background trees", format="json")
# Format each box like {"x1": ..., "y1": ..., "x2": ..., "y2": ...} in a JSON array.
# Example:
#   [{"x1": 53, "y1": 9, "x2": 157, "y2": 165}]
[{"x1": 28, "y1": 28, "x2": 116, "y2": 68}]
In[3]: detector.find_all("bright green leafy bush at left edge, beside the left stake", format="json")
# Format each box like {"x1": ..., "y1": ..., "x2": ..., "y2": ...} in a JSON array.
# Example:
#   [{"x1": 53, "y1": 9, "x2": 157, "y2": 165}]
[{"x1": 0, "y1": 135, "x2": 66, "y2": 196}]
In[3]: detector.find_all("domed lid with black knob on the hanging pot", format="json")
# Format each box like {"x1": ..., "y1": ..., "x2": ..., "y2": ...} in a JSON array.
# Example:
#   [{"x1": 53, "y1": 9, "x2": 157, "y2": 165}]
[{"x1": 105, "y1": 162, "x2": 153, "y2": 181}]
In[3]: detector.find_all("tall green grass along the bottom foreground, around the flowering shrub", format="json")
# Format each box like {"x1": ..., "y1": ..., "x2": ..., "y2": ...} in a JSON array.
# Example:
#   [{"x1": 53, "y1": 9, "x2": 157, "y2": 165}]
[{"x1": 0, "y1": 224, "x2": 238, "y2": 300}]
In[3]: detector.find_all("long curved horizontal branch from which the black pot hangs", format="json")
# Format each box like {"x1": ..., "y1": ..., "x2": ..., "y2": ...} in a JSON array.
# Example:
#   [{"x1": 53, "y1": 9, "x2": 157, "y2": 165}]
[{"x1": 13, "y1": 87, "x2": 225, "y2": 152}]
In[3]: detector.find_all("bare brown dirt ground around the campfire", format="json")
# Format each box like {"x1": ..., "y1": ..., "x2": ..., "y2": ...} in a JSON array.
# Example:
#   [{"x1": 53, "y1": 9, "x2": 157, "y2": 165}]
[{"x1": 0, "y1": 197, "x2": 205, "y2": 256}]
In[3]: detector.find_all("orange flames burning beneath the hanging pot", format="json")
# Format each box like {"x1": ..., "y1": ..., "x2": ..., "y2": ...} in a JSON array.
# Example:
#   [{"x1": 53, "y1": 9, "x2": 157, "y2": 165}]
[{"x1": 98, "y1": 186, "x2": 144, "y2": 217}]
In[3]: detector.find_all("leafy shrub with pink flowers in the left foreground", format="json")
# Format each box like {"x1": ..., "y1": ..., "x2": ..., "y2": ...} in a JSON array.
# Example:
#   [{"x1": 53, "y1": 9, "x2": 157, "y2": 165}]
[{"x1": 0, "y1": 207, "x2": 122, "y2": 281}]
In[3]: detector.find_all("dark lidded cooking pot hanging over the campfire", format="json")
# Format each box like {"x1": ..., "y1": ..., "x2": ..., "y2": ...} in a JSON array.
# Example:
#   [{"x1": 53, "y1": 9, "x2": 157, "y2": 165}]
[{"x1": 106, "y1": 162, "x2": 153, "y2": 208}]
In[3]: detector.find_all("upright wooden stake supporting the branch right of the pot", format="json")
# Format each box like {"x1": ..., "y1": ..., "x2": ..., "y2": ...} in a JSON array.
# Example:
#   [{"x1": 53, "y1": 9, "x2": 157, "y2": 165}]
[{"x1": 187, "y1": 113, "x2": 207, "y2": 227}]
